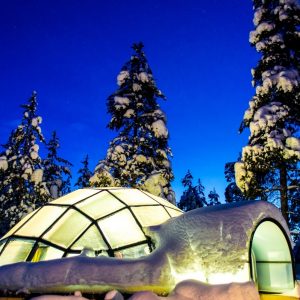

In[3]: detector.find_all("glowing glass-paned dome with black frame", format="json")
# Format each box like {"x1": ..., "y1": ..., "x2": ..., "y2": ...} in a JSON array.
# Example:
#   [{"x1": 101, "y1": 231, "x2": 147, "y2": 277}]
[{"x1": 0, "y1": 188, "x2": 182, "y2": 265}]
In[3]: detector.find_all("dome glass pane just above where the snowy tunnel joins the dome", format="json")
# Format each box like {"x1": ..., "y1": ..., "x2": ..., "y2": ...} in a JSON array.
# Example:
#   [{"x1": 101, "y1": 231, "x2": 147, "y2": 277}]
[{"x1": 132, "y1": 205, "x2": 170, "y2": 227}]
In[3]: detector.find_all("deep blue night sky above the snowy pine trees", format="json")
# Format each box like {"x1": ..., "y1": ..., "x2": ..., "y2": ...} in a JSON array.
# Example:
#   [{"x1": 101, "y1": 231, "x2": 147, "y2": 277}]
[{"x1": 0, "y1": 0, "x2": 258, "y2": 199}]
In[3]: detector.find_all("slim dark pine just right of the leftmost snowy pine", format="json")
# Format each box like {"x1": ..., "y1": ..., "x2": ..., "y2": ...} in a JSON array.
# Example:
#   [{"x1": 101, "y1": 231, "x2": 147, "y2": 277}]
[{"x1": 43, "y1": 131, "x2": 72, "y2": 199}]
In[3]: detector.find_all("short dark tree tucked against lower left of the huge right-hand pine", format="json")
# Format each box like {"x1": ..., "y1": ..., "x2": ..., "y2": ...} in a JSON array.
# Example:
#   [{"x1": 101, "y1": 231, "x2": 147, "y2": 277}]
[{"x1": 224, "y1": 162, "x2": 247, "y2": 203}]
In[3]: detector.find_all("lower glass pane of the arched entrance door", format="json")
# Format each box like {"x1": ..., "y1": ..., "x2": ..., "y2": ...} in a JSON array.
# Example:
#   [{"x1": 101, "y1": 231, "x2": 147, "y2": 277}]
[{"x1": 256, "y1": 262, "x2": 294, "y2": 293}]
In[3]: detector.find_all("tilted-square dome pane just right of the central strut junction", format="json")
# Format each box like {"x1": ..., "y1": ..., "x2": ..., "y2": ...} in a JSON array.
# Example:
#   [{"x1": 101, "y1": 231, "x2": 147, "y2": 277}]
[{"x1": 98, "y1": 209, "x2": 145, "y2": 248}]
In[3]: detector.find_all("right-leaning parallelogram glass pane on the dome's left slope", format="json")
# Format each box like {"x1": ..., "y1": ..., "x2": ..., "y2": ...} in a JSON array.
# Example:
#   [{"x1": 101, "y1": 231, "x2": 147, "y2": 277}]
[{"x1": 16, "y1": 205, "x2": 66, "y2": 237}]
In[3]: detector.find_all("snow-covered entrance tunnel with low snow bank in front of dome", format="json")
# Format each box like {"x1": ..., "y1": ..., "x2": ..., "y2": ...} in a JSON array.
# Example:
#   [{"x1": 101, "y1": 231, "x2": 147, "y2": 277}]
[{"x1": 0, "y1": 201, "x2": 288, "y2": 293}]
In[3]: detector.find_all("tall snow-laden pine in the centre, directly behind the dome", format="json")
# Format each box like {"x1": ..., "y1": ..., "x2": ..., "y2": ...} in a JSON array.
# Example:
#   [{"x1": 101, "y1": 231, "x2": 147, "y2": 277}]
[{"x1": 91, "y1": 43, "x2": 175, "y2": 203}]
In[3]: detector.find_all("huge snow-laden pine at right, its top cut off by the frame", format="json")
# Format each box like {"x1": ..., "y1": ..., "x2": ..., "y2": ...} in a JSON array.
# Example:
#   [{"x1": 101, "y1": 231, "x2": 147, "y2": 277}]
[{"x1": 235, "y1": 0, "x2": 300, "y2": 222}]
